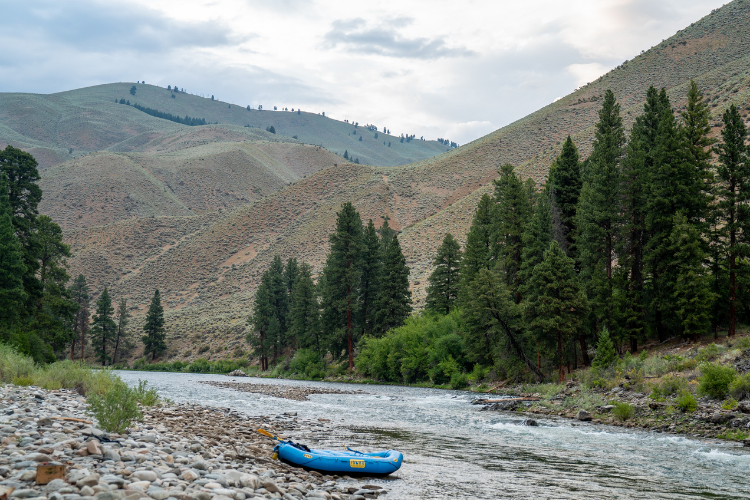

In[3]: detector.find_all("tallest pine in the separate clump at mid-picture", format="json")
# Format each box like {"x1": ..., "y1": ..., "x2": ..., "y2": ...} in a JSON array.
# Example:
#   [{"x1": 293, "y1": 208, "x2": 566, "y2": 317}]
[{"x1": 322, "y1": 202, "x2": 362, "y2": 370}]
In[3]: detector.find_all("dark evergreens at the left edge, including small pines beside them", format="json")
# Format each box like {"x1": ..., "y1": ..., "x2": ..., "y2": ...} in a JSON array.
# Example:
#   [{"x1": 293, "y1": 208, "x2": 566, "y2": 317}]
[{"x1": 0, "y1": 146, "x2": 166, "y2": 365}]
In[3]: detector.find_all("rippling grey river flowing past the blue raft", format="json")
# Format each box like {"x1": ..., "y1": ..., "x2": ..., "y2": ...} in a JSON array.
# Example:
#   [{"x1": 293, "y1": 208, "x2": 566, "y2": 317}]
[{"x1": 119, "y1": 371, "x2": 750, "y2": 499}]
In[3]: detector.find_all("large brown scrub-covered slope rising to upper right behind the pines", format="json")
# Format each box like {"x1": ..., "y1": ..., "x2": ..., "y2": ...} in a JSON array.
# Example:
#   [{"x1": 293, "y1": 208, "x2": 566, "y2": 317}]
[{"x1": 45, "y1": 0, "x2": 750, "y2": 358}]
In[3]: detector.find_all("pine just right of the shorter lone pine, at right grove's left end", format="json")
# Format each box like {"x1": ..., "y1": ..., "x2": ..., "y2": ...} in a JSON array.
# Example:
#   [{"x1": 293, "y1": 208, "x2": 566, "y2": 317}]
[{"x1": 458, "y1": 194, "x2": 496, "y2": 304}]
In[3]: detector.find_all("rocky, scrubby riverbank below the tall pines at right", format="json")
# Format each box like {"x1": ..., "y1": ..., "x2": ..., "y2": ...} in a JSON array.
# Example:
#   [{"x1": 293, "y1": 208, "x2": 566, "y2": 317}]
[{"x1": 476, "y1": 382, "x2": 750, "y2": 446}]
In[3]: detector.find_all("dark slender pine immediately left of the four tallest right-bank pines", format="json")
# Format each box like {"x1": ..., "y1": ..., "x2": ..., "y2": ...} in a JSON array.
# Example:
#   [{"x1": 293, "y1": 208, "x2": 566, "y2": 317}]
[{"x1": 549, "y1": 136, "x2": 583, "y2": 256}]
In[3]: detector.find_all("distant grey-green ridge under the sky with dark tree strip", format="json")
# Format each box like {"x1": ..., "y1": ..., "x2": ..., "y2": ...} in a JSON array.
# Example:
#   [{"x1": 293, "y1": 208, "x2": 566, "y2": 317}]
[{"x1": 0, "y1": 82, "x2": 447, "y2": 168}]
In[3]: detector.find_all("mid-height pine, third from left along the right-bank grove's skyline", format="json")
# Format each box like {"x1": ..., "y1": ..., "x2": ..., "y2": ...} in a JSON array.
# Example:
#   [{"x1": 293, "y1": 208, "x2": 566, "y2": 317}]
[{"x1": 491, "y1": 165, "x2": 531, "y2": 296}]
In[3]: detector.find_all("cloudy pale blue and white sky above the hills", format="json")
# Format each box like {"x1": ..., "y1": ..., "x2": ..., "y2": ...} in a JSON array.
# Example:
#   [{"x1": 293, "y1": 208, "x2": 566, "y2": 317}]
[{"x1": 0, "y1": 0, "x2": 726, "y2": 144}]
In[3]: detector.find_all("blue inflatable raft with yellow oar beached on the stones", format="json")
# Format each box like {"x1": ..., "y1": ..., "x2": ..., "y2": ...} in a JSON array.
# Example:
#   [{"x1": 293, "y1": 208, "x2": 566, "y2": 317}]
[{"x1": 274, "y1": 441, "x2": 404, "y2": 476}]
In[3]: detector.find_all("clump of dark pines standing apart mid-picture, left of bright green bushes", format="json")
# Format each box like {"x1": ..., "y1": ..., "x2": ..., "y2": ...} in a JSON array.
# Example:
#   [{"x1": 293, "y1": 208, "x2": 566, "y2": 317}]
[{"x1": 247, "y1": 208, "x2": 412, "y2": 370}]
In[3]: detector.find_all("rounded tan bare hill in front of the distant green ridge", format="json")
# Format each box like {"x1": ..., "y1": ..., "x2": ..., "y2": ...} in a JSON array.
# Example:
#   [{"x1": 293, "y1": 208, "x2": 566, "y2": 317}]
[{"x1": 40, "y1": 125, "x2": 341, "y2": 230}]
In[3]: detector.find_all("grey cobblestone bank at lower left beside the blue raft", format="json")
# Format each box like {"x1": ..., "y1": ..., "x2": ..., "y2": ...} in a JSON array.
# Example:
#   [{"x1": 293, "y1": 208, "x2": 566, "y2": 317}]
[{"x1": 0, "y1": 385, "x2": 394, "y2": 500}]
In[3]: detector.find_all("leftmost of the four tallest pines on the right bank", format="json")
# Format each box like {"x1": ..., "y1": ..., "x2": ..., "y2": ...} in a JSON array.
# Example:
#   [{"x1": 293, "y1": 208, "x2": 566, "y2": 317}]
[{"x1": 576, "y1": 90, "x2": 625, "y2": 332}]
